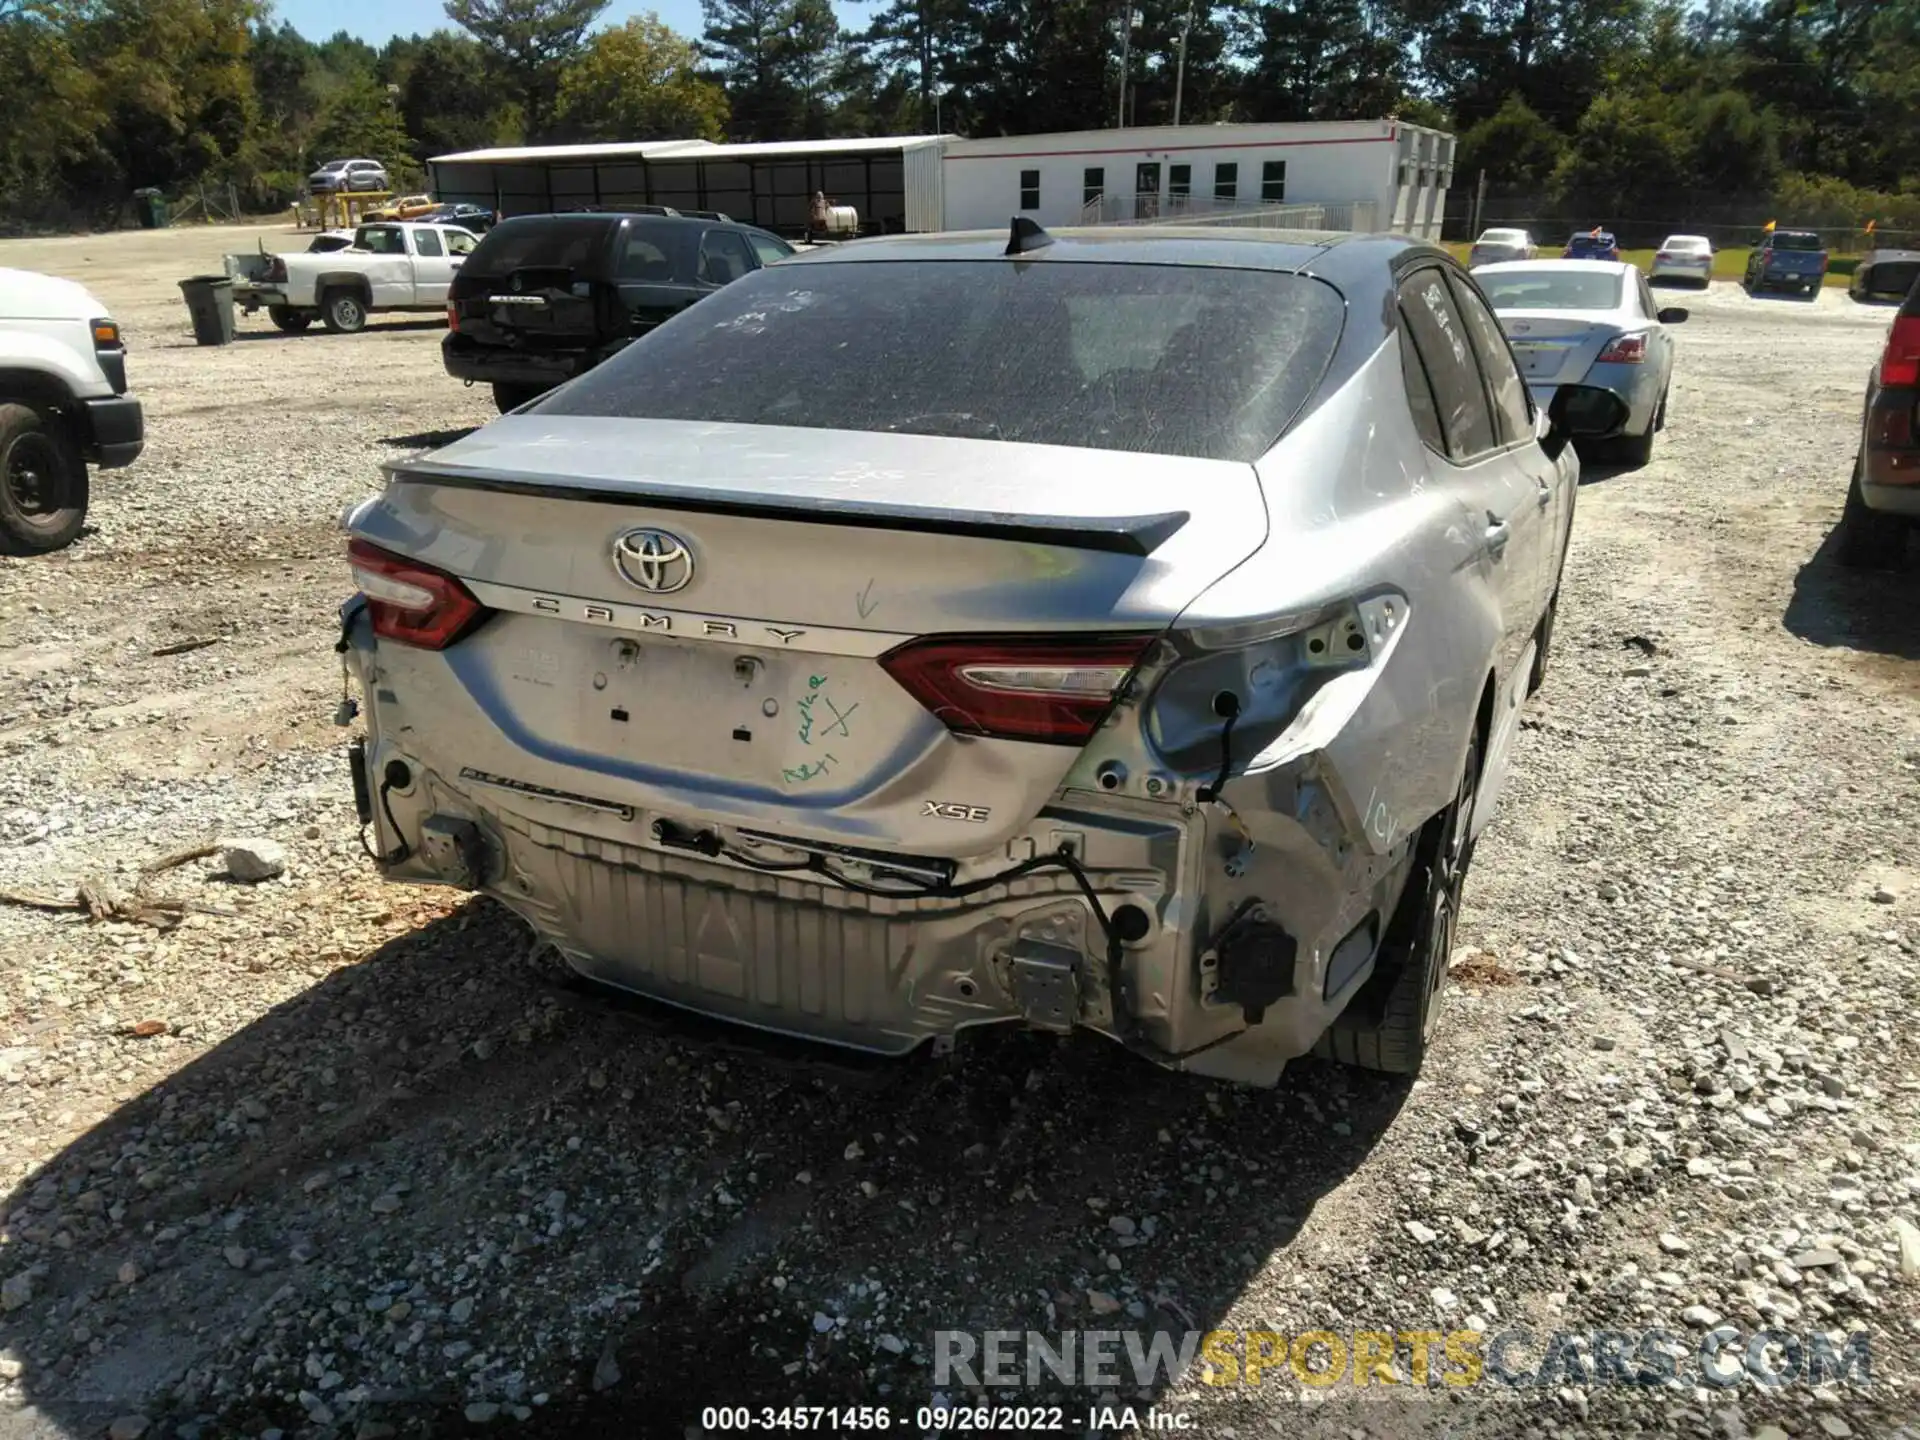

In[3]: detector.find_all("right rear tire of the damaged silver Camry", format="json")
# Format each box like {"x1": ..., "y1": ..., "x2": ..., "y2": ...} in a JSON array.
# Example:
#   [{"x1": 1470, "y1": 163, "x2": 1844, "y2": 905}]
[{"x1": 1313, "y1": 733, "x2": 1480, "y2": 1075}]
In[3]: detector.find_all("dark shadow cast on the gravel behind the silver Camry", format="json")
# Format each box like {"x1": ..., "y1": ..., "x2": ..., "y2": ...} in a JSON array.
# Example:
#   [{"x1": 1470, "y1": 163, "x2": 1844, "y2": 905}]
[{"x1": 0, "y1": 900, "x2": 1409, "y2": 1436}]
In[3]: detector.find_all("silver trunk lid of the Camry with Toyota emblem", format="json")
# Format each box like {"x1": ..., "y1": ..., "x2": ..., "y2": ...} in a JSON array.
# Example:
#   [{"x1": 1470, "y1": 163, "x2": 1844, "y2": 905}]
[{"x1": 351, "y1": 422, "x2": 1267, "y2": 858}]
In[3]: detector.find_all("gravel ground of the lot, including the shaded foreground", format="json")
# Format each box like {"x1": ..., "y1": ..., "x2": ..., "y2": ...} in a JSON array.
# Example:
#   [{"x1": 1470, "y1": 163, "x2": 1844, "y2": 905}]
[{"x1": 0, "y1": 230, "x2": 1920, "y2": 1440}]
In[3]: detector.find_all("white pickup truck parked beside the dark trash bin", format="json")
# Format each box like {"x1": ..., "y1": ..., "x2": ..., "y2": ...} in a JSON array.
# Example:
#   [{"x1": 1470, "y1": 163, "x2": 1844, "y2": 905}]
[{"x1": 227, "y1": 221, "x2": 480, "y2": 334}]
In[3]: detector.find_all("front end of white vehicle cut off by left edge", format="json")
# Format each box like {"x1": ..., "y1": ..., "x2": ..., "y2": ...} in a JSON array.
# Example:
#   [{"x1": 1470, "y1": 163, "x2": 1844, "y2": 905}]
[{"x1": 0, "y1": 269, "x2": 146, "y2": 553}]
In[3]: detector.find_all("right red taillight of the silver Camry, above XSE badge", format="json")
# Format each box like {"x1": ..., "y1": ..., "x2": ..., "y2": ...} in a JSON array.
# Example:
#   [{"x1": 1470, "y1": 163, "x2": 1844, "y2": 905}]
[{"x1": 879, "y1": 636, "x2": 1154, "y2": 745}]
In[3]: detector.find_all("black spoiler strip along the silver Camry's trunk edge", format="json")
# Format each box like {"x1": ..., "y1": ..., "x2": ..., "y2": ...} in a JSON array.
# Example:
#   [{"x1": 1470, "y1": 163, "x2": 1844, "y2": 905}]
[{"x1": 382, "y1": 459, "x2": 1190, "y2": 555}]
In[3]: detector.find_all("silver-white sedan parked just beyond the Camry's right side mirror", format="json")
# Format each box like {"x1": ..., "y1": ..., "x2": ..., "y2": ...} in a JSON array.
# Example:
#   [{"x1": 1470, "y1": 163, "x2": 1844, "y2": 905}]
[{"x1": 1473, "y1": 259, "x2": 1688, "y2": 465}]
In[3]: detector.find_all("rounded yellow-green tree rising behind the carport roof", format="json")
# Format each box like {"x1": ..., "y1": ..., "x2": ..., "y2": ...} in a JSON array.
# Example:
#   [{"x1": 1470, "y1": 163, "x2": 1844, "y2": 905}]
[{"x1": 555, "y1": 13, "x2": 728, "y2": 140}]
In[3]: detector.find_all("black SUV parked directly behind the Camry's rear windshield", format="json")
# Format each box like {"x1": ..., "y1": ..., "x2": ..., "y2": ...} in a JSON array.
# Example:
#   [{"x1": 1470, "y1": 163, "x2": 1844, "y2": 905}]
[{"x1": 440, "y1": 213, "x2": 793, "y2": 411}]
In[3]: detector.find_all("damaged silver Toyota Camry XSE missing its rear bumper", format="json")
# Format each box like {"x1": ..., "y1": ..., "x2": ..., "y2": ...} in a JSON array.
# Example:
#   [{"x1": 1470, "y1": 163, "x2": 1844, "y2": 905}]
[{"x1": 340, "y1": 221, "x2": 1613, "y2": 1085}]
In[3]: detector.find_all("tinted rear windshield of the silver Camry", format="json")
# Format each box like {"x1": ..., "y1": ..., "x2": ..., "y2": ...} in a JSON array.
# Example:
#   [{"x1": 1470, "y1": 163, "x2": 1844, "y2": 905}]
[{"x1": 540, "y1": 261, "x2": 1344, "y2": 461}]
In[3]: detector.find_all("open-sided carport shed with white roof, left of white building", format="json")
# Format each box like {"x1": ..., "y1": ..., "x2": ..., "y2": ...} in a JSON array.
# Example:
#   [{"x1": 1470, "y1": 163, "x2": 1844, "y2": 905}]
[{"x1": 428, "y1": 134, "x2": 943, "y2": 234}]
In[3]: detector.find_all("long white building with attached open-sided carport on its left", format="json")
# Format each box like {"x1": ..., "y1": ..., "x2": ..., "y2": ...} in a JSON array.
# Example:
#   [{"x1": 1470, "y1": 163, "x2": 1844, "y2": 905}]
[{"x1": 430, "y1": 119, "x2": 1453, "y2": 240}]
